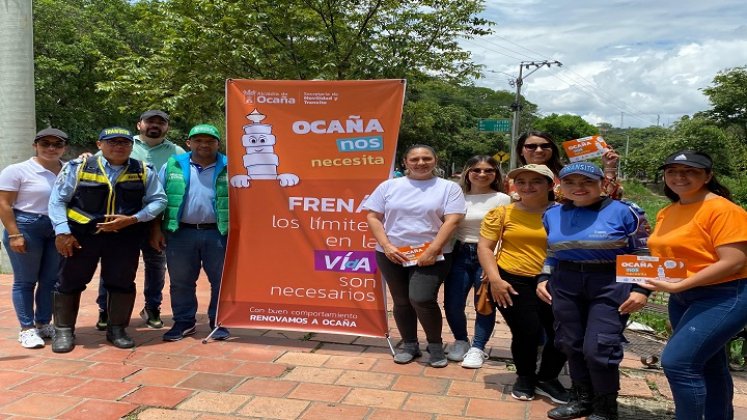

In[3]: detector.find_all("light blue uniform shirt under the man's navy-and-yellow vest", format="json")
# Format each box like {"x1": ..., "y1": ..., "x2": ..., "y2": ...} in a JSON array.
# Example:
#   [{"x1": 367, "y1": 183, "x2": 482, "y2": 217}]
[{"x1": 49, "y1": 156, "x2": 166, "y2": 235}]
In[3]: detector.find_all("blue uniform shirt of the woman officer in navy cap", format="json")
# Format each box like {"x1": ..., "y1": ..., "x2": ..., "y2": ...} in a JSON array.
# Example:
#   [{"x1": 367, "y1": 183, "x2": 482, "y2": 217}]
[{"x1": 542, "y1": 198, "x2": 640, "y2": 274}]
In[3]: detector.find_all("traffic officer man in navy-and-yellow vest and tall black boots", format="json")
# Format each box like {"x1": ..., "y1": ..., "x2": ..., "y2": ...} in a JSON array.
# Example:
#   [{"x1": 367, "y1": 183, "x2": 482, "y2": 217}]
[{"x1": 49, "y1": 127, "x2": 166, "y2": 353}]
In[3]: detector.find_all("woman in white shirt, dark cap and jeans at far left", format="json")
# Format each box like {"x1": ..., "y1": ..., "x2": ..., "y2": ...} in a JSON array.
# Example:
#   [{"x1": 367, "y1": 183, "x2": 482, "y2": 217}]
[{"x1": 0, "y1": 128, "x2": 68, "y2": 348}]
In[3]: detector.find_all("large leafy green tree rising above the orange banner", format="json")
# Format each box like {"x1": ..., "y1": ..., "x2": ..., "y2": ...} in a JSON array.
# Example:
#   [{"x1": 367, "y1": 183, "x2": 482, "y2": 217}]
[{"x1": 97, "y1": 0, "x2": 489, "y2": 125}]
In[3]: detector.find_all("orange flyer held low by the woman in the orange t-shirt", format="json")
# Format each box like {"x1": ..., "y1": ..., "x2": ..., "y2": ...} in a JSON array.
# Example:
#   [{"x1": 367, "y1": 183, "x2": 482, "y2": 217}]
[{"x1": 616, "y1": 255, "x2": 687, "y2": 283}]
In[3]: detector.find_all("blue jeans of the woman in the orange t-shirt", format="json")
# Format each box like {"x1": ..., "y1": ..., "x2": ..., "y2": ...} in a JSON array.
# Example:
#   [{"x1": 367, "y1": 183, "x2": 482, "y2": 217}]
[{"x1": 661, "y1": 279, "x2": 747, "y2": 420}]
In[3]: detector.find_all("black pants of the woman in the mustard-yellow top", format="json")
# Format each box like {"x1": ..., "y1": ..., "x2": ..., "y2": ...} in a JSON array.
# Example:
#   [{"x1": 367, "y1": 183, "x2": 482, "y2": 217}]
[{"x1": 498, "y1": 267, "x2": 566, "y2": 381}]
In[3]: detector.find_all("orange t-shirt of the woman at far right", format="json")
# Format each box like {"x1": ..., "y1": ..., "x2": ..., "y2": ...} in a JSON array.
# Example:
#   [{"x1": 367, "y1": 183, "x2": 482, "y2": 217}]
[{"x1": 648, "y1": 197, "x2": 747, "y2": 284}]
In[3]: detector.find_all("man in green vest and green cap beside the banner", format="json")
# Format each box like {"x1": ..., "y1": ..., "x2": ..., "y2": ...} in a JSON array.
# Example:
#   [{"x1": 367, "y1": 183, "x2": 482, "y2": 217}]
[{"x1": 150, "y1": 124, "x2": 230, "y2": 341}]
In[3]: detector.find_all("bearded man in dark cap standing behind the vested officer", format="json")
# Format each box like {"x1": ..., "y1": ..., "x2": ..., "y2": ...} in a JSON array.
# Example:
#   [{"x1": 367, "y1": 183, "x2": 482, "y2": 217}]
[{"x1": 96, "y1": 109, "x2": 186, "y2": 330}]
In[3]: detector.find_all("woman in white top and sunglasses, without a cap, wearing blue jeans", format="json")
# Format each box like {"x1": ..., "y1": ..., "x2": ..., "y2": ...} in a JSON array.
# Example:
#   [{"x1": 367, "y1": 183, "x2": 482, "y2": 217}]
[{"x1": 444, "y1": 155, "x2": 511, "y2": 362}]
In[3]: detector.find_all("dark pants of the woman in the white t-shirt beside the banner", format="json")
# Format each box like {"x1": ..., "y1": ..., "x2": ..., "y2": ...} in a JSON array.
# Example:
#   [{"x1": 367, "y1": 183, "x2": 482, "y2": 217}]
[{"x1": 376, "y1": 251, "x2": 451, "y2": 343}]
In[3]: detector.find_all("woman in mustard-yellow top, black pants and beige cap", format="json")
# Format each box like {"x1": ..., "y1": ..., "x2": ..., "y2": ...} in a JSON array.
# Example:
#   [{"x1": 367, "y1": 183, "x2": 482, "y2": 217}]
[{"x1": 480, "y1": 164, "x2": 568, "y2": 403}]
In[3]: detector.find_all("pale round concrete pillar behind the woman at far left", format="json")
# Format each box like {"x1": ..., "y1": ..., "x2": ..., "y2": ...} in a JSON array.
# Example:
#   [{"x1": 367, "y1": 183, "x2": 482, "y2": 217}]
[{"x1": 0, "y1": 0, "x2": 36, "y2": 273}]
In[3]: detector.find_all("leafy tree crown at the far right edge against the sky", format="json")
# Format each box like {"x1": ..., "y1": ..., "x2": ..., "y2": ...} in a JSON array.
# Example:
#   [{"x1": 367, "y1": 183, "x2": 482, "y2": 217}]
[{"x1": 703, "y1": 66, "x2": 747, "y2": 143}]
